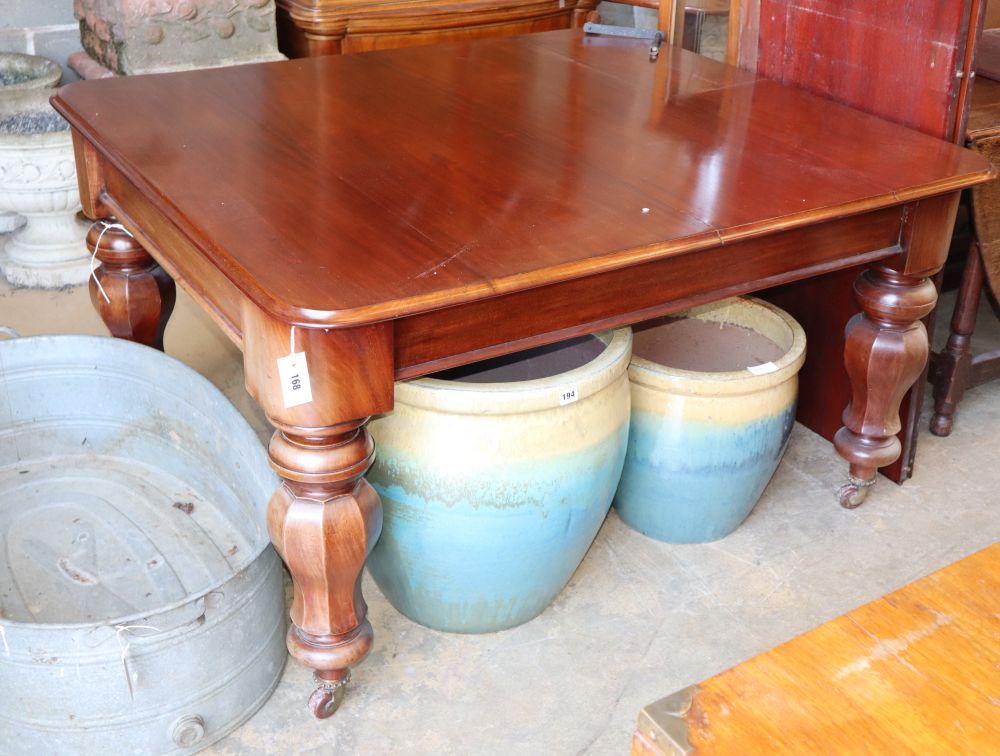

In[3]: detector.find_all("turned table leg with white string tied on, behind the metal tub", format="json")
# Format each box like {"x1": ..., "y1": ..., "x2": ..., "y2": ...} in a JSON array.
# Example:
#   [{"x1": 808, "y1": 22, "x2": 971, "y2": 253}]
[{"x1": 87, "y1": 218, "x2": 177, "y2": 352}]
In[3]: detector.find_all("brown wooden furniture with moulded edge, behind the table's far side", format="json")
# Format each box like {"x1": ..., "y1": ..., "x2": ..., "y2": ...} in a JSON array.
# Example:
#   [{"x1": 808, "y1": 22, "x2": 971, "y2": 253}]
[{"x1": 277, "y1": 0, "x2": 598, "y2": 58}]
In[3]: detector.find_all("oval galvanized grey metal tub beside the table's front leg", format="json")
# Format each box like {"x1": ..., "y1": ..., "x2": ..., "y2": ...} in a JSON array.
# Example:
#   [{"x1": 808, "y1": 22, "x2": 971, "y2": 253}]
[{"x1": 0, "y1": 336, "x2": 286, "y2": 754}]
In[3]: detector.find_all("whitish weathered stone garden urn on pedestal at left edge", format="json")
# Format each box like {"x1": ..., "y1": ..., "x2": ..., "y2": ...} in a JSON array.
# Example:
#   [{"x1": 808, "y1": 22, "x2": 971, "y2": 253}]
[{"x1": 0, "y1": 53, "x2": 90, "y2": 288}]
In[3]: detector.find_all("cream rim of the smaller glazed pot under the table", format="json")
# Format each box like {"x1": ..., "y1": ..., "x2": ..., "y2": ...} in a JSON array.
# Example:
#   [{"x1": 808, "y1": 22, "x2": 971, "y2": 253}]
[{"x1": 629, "y1": 297, "x2": 806, "y2": 396}]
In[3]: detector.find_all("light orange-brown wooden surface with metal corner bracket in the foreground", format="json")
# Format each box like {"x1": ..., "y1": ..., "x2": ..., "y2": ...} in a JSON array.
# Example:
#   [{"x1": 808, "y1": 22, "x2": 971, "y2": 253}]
[{"x1": 632, "y1": 543, "x2": 1000, "y2": 756}]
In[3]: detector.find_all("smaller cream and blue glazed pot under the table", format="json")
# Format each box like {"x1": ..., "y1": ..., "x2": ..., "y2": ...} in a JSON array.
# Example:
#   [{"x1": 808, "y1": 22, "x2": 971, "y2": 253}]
[{"x1": 615, "y1": 298, "x2": 806, "y2": 543}]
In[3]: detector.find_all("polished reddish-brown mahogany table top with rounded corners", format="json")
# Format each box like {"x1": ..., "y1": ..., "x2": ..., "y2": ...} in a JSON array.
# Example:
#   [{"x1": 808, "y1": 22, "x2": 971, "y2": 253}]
[{"x1": 54, "y1": 31, "x2": 986, "y2": 326}]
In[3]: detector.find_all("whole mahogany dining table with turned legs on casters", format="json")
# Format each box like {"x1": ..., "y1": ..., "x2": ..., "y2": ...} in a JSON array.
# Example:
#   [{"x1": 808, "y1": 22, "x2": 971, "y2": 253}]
[{"x1": 52, "y1": 30, "x2": 991, "y2": 717}]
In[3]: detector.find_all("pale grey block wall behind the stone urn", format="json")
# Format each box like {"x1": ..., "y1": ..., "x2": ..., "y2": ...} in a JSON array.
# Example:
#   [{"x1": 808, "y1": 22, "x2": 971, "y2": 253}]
[{"x1": 0, "y1": 0, "x2": 82, "y2": 83}]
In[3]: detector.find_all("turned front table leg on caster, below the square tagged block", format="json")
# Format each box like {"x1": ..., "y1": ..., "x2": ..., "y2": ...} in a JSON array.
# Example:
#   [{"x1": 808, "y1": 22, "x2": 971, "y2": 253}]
[{"x1": 267, "y1": 420, "x2": 382, "y2": 719}]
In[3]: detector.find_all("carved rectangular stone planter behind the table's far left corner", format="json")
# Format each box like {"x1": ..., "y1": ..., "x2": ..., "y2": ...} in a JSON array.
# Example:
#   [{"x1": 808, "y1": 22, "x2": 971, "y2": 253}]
[{"x1": 73, "y1": 0, "x2": 284, "y2": 75}]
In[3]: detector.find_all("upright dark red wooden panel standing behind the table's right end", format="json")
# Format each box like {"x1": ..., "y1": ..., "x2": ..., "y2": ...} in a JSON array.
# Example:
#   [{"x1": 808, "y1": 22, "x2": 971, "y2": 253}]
[{"x1": 739, "y1": 0, "x2": 980, "y2": 482}]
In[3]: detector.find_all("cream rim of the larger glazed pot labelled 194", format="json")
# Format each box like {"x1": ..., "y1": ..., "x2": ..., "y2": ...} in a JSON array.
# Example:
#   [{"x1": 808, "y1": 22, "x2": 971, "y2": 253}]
[{"x1": 396, "y1": 328, "x2": 632, "y2": 415}]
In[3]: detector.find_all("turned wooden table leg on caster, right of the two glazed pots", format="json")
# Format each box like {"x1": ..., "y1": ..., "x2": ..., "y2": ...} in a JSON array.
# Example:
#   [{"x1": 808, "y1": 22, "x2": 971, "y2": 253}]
[{"x1": 834, "y1": 265, "x2": 937, "y2": 509}]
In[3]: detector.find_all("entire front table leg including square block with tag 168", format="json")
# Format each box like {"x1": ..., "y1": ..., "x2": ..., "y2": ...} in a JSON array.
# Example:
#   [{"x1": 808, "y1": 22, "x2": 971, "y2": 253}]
[{"x1": 241, "y1": 310, "x2": 394, "y2": 718}]
